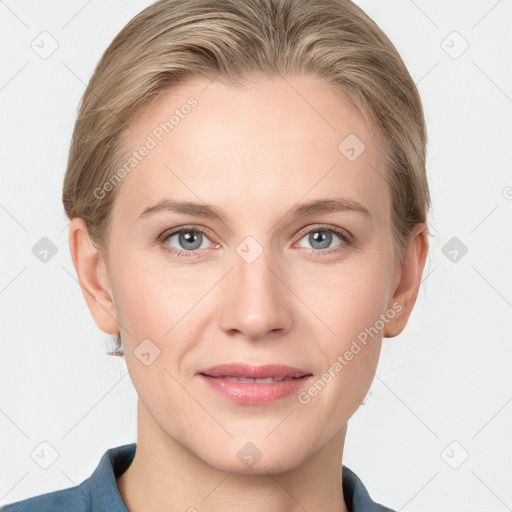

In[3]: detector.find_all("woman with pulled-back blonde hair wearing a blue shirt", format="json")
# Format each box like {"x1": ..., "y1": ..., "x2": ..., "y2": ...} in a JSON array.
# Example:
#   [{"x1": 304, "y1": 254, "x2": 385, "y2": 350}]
[{"x1": 3, "y1": 0, "x2": 430, "y2": 512}]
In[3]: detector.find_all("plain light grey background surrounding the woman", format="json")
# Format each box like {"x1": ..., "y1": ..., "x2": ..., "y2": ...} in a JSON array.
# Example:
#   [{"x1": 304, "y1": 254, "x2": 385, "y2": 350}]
[{"x1": 0, "y1": 0, "x2": 512, "y2": 512}]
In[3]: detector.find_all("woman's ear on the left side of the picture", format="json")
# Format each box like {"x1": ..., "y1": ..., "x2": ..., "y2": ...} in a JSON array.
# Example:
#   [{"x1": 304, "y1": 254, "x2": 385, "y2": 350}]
[{"x1": 68, "y1": 217, "x2": 119, "y2": 334}]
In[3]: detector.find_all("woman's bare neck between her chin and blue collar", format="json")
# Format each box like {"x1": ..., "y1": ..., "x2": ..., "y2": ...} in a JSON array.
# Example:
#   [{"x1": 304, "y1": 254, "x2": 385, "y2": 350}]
[{"x1": 117, "y1": 401, "x2": 348, "y2": 512}]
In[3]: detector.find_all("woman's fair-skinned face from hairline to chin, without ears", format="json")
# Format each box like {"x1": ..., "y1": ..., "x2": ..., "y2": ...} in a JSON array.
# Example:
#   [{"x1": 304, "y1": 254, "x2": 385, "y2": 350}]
[{"x1": 86, "y1": 77, "x2": 420, "y2": 473}]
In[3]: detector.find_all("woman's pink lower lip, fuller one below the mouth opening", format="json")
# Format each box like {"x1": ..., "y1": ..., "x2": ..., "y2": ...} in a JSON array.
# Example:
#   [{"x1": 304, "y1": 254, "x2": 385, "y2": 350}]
[{"x1": 200, "y1": 375, "x2": 311, "y2": 405}]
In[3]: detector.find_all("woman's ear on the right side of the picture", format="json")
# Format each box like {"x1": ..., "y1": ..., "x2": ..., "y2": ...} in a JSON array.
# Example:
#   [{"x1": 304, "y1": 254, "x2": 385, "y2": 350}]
[{"x1": 383, "y1": 223, "x2": 428, "y2": 338}]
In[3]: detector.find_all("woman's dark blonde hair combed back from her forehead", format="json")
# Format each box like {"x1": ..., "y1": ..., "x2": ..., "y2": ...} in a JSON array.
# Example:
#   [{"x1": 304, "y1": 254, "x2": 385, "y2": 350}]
[{"x1": 62, "y1": 0, "x2": 430, "y2": 354}]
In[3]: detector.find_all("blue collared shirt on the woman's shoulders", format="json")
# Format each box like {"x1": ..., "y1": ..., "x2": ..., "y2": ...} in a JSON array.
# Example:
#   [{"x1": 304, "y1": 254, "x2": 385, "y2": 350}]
[{"x1": 0, "y1": 443, "x2": 394, "y2": 512}]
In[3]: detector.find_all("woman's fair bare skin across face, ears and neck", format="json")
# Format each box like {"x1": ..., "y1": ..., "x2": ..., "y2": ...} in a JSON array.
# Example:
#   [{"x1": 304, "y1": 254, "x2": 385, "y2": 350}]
[{"x1": 69, "y1": 76, "x2": 428, "y2": 512}]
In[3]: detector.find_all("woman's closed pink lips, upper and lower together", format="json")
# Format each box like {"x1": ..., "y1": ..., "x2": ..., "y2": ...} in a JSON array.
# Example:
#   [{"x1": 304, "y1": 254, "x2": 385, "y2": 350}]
[{"x1": 198, "y1": 363, "x2": 312, "y2": 405}]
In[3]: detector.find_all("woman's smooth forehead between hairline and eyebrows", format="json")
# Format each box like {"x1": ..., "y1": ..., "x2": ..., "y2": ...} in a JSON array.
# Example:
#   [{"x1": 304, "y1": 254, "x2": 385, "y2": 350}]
[{"x1": 116, "y1": 76, "x2": 390, "y2": 224}]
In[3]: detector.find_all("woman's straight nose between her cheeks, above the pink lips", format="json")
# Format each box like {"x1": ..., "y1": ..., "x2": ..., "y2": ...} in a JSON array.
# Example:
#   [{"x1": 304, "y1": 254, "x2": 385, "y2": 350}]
[{"x1": 220, "y1": 245, "x2": 293, "y2": 341}]
